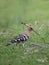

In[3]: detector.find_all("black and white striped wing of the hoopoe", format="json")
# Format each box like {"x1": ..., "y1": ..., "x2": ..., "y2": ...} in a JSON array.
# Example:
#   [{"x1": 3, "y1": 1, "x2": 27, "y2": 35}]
[{"x1": 11, "y1": 34, "x2": 29, "y2": 43}]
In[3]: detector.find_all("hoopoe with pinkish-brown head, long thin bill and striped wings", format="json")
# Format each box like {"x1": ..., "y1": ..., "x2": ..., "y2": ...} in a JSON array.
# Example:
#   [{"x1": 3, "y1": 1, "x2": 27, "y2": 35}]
[{"x1": 6, "y1": 22, "x2": 38, "y2": 46}]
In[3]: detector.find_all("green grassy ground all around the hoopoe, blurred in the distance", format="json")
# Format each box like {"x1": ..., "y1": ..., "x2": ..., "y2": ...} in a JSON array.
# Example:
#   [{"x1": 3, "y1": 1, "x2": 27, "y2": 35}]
[{"x1": 0, "y1": 0, "x2": 49, "y2": 65}]
